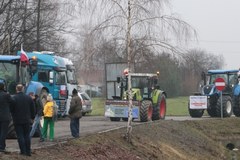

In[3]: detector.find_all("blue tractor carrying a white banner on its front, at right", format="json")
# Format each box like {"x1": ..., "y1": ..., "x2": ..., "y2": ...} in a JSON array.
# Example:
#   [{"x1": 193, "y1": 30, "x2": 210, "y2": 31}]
[{"x1": 188, "y1": 70, "x2": 240, "y2": 118}]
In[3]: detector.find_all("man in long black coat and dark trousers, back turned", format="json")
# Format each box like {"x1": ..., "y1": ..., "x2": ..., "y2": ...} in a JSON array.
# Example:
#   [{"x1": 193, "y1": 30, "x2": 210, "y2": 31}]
[{"x1": 11, "y1": 84, "x2": 35, "y2": 156}]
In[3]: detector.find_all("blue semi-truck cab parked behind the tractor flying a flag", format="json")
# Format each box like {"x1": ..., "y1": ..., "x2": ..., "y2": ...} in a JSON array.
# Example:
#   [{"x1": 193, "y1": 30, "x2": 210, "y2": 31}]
[{"x1": 18, "y1": 51, "x2": 68, "y2": 117}]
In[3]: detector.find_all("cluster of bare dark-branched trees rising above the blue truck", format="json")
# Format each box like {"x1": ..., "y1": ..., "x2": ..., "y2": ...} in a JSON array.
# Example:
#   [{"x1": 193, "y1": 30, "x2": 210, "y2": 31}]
[{"x1": 0, "y1": 0, "x2": 69, "y2": 54}]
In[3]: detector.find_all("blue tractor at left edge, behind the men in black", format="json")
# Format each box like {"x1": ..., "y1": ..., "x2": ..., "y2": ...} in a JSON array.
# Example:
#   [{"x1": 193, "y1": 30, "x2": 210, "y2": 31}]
[{"x1": 0, "y1": 55, "x2": 44, "y2": 138}]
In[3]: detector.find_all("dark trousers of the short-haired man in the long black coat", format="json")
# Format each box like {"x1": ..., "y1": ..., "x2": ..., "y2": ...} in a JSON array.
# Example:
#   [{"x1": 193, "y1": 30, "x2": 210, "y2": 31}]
[{"x1": 14, "y1": 123, "x2": 31, "y2": 155}]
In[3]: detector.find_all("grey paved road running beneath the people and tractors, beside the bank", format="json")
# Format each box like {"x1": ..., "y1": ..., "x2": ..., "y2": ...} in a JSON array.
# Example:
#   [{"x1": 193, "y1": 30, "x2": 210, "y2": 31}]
[{"x1": 6, "y1": 116, "x2": 208, "y2": 152}]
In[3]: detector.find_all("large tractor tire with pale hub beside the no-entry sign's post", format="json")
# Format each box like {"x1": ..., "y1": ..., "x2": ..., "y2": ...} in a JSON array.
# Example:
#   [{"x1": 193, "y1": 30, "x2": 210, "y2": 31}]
[{"x1": 216, "y1": 96, "x2": 233, "y2": 117}]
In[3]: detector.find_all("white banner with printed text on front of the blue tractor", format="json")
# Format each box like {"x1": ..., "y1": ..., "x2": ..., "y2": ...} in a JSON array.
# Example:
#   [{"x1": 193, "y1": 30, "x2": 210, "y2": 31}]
[{"x1": 189, "y1": 96, "x2": 207, "y2": 109}]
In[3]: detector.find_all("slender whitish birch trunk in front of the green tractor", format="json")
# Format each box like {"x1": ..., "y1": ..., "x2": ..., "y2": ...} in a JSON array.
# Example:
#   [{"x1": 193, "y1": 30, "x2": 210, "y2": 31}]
[{"x1": 127, "y1": 0, "x2": 133, "y2": 142}]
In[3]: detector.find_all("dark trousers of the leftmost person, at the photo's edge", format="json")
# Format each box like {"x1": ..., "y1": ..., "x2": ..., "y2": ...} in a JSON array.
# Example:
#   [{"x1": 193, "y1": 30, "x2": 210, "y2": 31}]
[{"x1": 0, "y1": 121, "x2": 10, "y2": 151}]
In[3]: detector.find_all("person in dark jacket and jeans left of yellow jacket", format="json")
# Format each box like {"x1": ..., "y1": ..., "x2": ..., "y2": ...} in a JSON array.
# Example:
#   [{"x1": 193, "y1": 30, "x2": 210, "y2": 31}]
[{"x1": 30, "y1": 93, "x2": 44, "y2": 142}]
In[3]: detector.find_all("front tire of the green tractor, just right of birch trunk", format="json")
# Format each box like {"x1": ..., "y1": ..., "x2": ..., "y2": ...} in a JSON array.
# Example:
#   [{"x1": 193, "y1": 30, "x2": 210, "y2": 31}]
[{"x1": 140, "y1": 100, "x2": 153, "y2": 122}]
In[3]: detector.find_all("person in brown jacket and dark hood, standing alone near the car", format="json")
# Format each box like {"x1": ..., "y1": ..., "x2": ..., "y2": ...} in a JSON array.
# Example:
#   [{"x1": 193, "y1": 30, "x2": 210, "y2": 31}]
[{"x1": 68, "y1": 89, "x2": 82, "y2": 138}]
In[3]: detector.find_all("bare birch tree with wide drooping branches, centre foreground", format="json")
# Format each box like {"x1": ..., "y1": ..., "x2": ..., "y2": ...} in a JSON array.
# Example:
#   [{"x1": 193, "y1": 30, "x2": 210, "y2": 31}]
[{"x1": 68, "y1": 0, "x2": 196, "y2": 142}]
